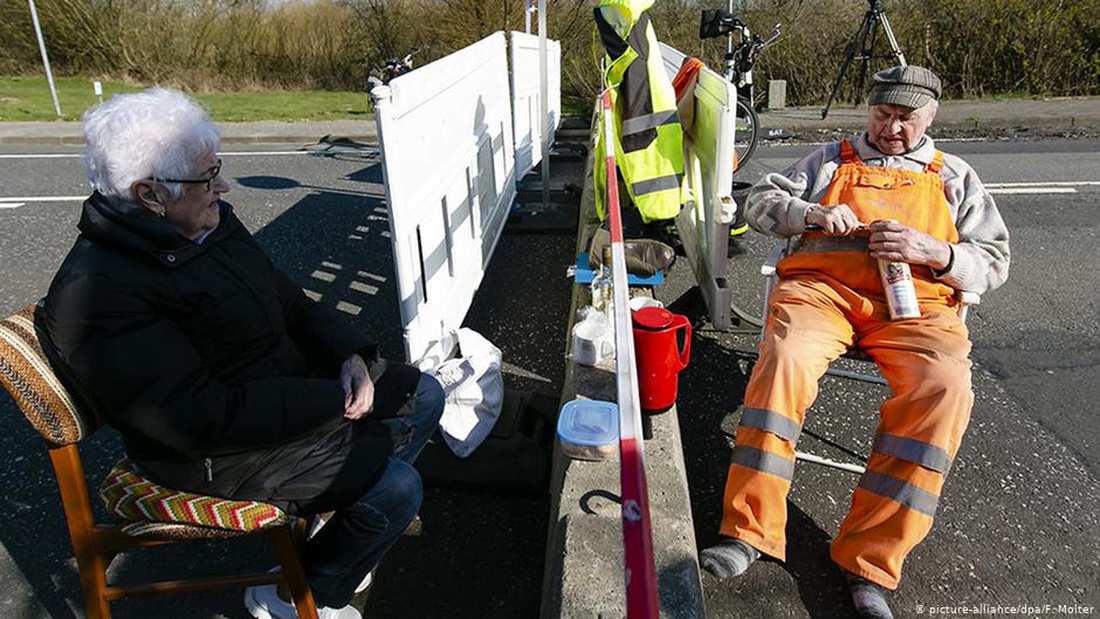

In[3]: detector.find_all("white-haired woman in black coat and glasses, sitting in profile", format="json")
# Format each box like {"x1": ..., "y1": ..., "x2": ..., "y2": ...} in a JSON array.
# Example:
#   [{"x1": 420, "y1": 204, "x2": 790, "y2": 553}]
[{"x1": 35, "y1": 88, "x2": 443, "y2": 619}]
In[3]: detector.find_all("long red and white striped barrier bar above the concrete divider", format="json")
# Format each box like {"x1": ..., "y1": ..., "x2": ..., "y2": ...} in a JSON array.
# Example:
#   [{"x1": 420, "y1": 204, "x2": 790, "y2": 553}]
[{"x1": 601, "y1": 90, "x2": 659, "y2": 619}]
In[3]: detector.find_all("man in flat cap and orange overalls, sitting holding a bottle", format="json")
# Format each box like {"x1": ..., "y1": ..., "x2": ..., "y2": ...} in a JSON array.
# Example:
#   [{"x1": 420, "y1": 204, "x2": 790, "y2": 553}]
[{"x1": 701, "y1": 65, "x2": 1009, "y2": 617}]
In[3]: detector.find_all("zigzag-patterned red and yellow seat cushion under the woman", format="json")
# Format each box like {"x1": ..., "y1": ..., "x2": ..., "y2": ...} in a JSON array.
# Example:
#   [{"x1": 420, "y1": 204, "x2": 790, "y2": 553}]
[{"x1": 99, "y1": 457, "x2": 295, "y2": 537}]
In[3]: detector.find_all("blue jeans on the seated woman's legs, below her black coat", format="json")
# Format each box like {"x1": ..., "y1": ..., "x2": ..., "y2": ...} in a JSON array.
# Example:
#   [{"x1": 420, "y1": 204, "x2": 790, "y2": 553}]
[{"x1": 306, "y1": 375, "x2": 444, "y2": 608}]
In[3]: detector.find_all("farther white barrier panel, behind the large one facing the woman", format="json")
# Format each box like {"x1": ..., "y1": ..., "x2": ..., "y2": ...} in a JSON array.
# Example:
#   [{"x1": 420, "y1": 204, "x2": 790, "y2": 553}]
[{"x1": 512, "y1": 32, "x2": 561, "y2": 178}]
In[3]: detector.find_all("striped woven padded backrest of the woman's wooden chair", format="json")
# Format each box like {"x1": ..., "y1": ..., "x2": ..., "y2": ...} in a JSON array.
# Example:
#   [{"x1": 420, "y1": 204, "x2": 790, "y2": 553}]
[{"x1": 0, "y1": 306, "x2": 99, "y2": 447}]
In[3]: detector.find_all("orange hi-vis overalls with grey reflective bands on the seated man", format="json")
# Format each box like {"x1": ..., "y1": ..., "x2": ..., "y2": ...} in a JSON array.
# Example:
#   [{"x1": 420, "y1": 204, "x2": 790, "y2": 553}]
[{"x1": 721, "y1": 141, "x2": 974, "y2": 589}]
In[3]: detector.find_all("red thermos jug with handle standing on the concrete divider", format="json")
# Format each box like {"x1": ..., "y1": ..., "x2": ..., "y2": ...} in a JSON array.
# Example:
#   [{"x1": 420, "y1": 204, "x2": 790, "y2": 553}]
[{"x1": 633, "y1": 308, "x2": 691, "y2": 413}]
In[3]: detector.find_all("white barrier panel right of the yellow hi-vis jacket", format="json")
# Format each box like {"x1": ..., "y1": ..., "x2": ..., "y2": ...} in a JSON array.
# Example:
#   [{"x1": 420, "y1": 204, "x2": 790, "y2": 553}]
[{"x1": 661, "y1": 43, "x2": 737, "y2": 329}]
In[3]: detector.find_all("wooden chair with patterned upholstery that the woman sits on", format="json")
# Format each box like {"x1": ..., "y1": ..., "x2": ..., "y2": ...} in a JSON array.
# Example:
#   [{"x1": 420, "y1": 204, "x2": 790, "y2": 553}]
[{"x1": 0, "y1": 306, "x2": 317, "y2": 619}]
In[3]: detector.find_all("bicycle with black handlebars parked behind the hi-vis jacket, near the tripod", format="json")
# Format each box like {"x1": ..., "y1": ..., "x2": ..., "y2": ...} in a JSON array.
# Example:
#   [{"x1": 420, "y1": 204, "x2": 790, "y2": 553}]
[{"x1": 699, "y1": 7, "x2": 782, "y2": 172}]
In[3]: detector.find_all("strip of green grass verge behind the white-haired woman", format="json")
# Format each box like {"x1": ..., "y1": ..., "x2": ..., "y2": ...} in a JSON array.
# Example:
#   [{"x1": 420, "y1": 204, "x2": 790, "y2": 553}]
[{"x1": 0, "y1": 77, "x2": 371, "y2": 122}]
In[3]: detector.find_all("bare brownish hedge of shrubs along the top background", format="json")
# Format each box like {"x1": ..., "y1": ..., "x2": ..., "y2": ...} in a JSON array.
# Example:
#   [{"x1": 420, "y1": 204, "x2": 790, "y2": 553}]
[{"x1": 0, "y1": 0, "x2": 1100, "y2": 103}]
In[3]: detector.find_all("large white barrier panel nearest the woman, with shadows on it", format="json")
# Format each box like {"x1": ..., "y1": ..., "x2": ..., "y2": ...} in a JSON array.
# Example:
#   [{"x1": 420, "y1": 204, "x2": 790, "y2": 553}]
[{"x1": 372, "y1": 32, "x2": 516, "y2": 362}]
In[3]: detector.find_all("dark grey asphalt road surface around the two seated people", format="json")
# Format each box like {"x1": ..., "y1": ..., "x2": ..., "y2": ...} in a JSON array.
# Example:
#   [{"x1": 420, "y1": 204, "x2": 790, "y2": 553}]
[{"x1": 0, "y1": 140, "x2": 1100, "y2": 619}]
